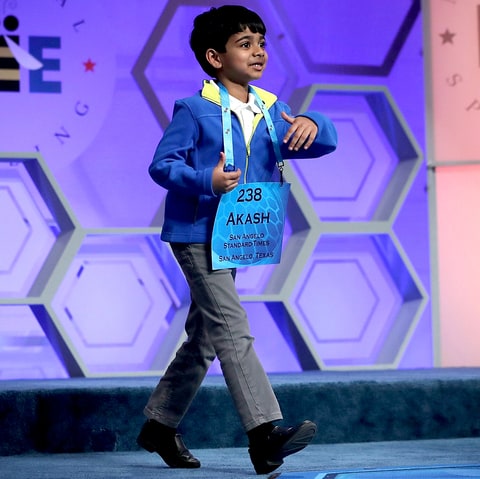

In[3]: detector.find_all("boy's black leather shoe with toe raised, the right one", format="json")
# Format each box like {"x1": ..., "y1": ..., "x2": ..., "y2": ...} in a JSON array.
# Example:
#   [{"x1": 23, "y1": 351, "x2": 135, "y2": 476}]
[{"x1": 248, "y1": 421, "x2": 317, "y2": 474}]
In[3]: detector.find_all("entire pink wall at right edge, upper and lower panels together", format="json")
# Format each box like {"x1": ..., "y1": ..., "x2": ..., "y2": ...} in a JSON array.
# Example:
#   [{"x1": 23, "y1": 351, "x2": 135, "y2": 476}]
[{"x1": 424, "y1": 0, "x2": 480, "y2": 366}]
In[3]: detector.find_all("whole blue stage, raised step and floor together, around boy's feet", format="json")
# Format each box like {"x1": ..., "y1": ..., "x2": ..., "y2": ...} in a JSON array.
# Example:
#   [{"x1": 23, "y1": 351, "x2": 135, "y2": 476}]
[{"x1": 0, "y1": 369, "x2": 480, "y2": 479}]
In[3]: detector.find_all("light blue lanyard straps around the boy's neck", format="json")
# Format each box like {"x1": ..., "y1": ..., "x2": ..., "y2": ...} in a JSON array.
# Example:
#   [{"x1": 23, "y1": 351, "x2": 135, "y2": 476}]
[{"x1": 218, "y1": 82, "x2": 284, "y2": 183}]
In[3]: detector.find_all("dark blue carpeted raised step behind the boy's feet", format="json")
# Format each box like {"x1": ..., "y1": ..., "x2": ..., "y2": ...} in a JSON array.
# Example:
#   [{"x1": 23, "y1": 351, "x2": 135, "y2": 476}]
[{"x1": 0, "y1": 369, "x2": 480, "y2": 455}]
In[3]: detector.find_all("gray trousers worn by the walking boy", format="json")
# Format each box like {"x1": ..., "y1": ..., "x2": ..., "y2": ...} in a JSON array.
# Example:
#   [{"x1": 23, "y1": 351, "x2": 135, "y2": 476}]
[{"x1": 144, "y1": 243, "x2": 282, "y2": 431}]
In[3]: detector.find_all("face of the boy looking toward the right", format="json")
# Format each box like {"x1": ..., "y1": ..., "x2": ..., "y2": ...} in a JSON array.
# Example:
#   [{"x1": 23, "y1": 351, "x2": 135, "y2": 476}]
[{"x1": 214, "y1": 28, "x2": 268, "y2": 85}]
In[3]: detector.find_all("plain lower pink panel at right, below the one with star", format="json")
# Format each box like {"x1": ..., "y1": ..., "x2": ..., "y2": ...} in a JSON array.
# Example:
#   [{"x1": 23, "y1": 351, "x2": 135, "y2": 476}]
[{"x1": 436, "y1": 165, "x2": 480, "y2": 366}]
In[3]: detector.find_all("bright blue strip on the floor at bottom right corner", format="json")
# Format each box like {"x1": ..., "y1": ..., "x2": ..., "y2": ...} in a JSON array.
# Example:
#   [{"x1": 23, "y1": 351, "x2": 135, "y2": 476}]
[{"x1": 278, "y1": 464, "x2": 480, "y2": 479}]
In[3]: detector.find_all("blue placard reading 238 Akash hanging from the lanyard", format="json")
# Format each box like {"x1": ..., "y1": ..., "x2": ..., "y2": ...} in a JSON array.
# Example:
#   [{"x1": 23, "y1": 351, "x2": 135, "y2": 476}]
[{"x1": 212, "y1": 182, "x2": 290, "y2": 269}]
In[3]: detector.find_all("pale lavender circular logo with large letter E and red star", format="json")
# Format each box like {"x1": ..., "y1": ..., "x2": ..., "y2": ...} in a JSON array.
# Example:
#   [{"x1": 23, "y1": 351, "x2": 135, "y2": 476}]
[{"x1": 0, "y1": 0, "x2": 115, "y2": 166}]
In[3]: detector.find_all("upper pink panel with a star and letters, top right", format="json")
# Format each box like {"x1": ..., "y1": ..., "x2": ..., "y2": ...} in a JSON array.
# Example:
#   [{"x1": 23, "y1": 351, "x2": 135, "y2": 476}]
[{"x1": 426, "y1": 0, "x2": 480, "y2": 162}]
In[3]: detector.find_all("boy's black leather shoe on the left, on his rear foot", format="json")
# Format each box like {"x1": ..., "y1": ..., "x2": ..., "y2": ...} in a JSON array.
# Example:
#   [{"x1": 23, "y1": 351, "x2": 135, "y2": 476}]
[{"x1": 137, "y1": 420, "x2": 200, "y2": 469}]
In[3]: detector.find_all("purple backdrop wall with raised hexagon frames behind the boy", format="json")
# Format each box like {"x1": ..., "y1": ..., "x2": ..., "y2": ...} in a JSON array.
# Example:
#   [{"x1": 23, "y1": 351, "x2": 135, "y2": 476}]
[{"x1": 0, "y1": 0, "x2": 433, "y2": 379}]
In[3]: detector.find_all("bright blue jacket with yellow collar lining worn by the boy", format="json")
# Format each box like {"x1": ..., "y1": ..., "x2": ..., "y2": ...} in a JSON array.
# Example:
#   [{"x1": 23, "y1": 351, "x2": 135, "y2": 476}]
[{"x1": 149, "y1": 80, "x2": 337, "y2": 243}]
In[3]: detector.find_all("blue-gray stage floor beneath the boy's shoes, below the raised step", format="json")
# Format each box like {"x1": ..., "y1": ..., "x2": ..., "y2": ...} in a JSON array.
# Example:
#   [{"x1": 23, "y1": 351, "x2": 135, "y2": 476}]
[{"x1": 0, "y1": 438, "x2": 480, "y2": 479}]
